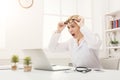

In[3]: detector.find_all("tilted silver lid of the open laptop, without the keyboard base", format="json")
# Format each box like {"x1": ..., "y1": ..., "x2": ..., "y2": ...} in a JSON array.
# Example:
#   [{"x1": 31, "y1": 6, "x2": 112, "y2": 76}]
[{"x1": 23, "y1": 49, "x2": 52, "y2": 70}]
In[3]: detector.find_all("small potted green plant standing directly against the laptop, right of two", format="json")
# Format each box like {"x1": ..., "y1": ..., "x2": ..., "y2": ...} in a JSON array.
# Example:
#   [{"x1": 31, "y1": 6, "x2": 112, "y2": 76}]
[{"x1": 24, "y1": 56, "x2": 32, "y2": 72}]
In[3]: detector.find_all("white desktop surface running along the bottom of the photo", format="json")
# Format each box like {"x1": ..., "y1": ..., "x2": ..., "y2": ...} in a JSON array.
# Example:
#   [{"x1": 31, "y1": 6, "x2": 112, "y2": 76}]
[{"x1": 0, "y1": 70, "x2": 120, "y2": 80}]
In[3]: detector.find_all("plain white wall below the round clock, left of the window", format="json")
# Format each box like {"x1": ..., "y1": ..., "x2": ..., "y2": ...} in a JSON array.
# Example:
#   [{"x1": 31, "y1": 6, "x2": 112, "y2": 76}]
[{"x1": 3, "y1": 0, "x2": 43, "y2": 49}]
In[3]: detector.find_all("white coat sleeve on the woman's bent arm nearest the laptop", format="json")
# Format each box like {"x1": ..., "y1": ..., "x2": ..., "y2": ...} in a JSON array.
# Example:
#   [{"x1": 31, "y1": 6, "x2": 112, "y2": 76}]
[{"x1": 48, "y1": 33, "x2": 69, "y2": 52}]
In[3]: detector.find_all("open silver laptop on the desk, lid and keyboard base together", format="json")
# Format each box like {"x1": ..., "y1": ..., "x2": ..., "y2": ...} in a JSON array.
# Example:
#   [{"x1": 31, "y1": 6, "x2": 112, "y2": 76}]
[{"x1": 23, "y1": 49, "x2": 71, "y2": 71}]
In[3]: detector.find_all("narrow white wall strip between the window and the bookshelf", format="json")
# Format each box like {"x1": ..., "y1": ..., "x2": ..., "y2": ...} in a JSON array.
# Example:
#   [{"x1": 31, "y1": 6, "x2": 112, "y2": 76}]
[{"x1": 92, "y1": 0, "x2": 108, "y2": 57}]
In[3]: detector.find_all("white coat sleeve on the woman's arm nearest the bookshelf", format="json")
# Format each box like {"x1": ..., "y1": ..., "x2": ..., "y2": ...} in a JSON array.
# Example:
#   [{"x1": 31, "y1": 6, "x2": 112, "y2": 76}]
[{"x1": 80, "y1": 26, "x2": 101, "y2": 49}]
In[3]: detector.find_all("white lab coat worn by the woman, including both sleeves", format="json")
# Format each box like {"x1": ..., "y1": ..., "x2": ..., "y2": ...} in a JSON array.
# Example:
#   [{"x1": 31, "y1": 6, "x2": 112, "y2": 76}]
[{"x1": 49, "y1": 27, "x2": 101, "y2": 68}]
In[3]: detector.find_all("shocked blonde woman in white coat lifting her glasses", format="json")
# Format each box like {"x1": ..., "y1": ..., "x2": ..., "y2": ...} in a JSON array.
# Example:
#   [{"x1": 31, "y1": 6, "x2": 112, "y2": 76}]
[{"x1": 49, "y1": 15, "x2": 101, "y2": 68}]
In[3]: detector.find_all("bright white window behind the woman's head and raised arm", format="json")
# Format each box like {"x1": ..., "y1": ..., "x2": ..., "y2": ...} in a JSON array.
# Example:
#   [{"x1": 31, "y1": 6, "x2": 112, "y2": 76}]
[{"x1": 43, "y1": 0, "x2": 92, "y2": 48}]
